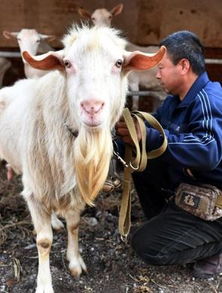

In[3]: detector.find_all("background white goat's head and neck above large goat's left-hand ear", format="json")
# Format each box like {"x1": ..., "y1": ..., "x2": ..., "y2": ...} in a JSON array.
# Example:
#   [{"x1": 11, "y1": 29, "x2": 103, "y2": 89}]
[{"x1": 3, "y1": 29, "x2": 55, "y2": 78}]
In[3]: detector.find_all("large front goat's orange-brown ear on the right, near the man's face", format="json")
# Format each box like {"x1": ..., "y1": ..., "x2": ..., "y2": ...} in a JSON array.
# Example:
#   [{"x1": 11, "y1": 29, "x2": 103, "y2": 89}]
[{"x1": 123, "y1": 46, "x2": 166, "y2": 72}]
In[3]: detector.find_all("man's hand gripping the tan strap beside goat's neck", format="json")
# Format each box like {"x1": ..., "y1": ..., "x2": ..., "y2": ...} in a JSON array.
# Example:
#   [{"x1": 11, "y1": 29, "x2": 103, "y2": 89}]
[{"x1": 115, "y1": 117, "x2": 142, "y2": 146}]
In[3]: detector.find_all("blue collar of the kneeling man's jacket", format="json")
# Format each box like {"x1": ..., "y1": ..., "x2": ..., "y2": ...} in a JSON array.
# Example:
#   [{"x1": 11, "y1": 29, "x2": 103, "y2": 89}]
[{"x1": 175, "y1": 72, "x2": 210, "y2": 108}]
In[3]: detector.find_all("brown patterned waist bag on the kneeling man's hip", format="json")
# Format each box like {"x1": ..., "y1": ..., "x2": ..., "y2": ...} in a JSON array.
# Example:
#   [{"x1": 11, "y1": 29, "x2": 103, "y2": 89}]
[{"x1": 175, "y1": 183, "x2": 222, "y2": 221}]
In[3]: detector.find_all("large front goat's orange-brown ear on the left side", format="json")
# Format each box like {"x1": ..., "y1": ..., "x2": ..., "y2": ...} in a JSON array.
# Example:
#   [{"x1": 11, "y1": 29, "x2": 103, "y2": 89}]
[{"x1": 22, "y1": 50, "x2": 65, "y2": 71}]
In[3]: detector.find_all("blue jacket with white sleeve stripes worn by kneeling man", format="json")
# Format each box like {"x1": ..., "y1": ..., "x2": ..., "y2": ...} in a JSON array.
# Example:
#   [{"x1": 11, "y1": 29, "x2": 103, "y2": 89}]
[{"x1": 147, "y1": 72, "x2": 222, "y2": 188}]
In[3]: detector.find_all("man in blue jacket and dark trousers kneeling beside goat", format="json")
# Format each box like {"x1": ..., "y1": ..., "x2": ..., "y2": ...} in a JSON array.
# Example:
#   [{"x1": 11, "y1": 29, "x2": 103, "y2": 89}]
[{"x1": 116, "y1": 31, "x2": 222, "y2": 278}]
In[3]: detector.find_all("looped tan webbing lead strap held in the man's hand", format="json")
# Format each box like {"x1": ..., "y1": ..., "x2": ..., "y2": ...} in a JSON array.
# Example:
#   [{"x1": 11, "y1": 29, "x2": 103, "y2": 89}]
[{"x1": 118, "y1": 108, "x2": 167, "y2": 237}]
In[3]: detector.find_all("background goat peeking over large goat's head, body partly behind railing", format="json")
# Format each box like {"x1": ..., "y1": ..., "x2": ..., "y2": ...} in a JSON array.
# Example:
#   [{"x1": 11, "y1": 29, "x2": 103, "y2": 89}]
[{"x1": 78, "y1": 3, "x2": 166, "y2": 110}]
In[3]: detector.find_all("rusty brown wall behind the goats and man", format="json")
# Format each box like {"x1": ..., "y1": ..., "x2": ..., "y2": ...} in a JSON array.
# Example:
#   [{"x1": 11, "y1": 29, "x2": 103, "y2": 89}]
[{"x1": 0, "y1": 0, "x2": 222, "y2": 48}]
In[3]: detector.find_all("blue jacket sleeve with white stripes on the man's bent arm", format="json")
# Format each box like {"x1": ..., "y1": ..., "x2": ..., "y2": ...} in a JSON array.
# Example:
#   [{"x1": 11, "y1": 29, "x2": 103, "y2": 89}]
[{"x1": 147, "y1": 92, "x2": 222, "y2": 171}]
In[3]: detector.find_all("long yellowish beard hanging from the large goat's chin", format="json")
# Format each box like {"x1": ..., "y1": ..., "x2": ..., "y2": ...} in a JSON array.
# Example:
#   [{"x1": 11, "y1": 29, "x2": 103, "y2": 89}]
[{"x1": 74, "y1": 127, "x2": 113, "y2": 206}]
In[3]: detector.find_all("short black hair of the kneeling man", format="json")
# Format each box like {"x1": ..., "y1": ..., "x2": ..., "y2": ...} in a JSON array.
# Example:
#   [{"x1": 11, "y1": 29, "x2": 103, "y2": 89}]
[{"x1": 160, "y1": 31, "x2": 205, "y2": 75}]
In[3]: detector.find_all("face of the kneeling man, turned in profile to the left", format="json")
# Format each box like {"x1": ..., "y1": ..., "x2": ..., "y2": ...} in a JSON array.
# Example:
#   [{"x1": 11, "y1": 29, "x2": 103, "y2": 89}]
[{"x1": 156, "y1": 53, "x2": 182, "y2": 95}]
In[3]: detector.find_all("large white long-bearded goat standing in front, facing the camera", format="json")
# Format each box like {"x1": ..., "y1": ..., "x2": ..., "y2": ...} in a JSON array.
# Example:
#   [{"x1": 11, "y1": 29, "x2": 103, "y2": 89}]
[{"x1": 0, "y1": 27, "x2": 165, "y2": 293}]
